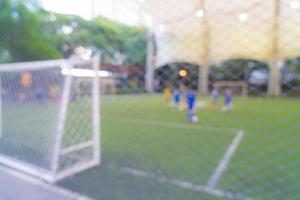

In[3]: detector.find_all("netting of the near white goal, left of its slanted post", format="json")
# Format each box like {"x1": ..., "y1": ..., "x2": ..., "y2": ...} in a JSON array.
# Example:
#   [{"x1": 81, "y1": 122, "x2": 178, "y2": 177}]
[{"x1": 0, "y1": 69, "x2": 63, "y2": 169}]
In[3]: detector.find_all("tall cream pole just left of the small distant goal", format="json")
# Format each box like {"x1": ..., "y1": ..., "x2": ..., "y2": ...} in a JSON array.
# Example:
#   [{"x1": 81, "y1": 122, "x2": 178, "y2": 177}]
[{"x1": 198, "y1": 0, "x2": 210, "y2": 95}]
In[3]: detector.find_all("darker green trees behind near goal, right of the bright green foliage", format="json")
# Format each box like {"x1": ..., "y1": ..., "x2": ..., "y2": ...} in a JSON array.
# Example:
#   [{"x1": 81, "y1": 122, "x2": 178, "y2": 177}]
[{"x1": 39, "y1": 11, "x2": 146, "y2": 66}]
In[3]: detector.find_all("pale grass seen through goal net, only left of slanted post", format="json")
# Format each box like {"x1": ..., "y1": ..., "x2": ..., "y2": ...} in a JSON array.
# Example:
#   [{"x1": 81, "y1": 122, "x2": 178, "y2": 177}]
[{"x1": 0, "y1": 101, "x2": 59, "y2": 169}]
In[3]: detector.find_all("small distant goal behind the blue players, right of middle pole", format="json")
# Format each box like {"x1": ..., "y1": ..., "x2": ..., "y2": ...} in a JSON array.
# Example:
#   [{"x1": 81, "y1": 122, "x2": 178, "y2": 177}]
[{"x1": 213, "y1": 81, "x2": 248, "y2": 96}]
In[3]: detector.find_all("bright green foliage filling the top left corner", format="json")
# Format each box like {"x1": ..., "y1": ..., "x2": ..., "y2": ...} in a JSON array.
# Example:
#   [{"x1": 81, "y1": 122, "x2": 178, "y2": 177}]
[{"x1": 0, "y1": 0, "x2": 61, "y2": 61}]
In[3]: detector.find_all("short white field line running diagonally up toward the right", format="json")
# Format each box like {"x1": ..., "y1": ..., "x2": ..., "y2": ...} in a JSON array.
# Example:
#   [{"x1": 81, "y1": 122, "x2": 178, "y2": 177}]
[{"x1": 207, "y1": 130, "x2": 244, "y2": 189}]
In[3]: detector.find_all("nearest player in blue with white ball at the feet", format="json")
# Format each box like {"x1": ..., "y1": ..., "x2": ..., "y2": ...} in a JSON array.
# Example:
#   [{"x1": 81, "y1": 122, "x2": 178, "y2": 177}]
[{"x1": 185, "y1": 86, "x2": 198, "y2": 123}]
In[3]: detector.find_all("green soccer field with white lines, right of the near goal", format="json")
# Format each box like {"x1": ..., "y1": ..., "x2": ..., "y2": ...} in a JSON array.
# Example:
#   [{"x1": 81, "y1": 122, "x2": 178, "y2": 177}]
[{"x1": 4, "y1": 96, "x2": 300, "y2": 200}]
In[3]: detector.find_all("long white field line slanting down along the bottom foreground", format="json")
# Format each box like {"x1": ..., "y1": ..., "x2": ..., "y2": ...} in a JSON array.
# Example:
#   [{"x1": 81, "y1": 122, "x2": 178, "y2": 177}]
[{"x1": 121, "y1": 167, "x2": 254, "y2": 200}]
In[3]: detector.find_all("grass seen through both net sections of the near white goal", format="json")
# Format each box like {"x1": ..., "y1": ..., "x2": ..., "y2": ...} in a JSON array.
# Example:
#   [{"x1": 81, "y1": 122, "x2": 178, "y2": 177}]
[{"x1": 0, "y1": 100, "x2": 93, "y2": 169}]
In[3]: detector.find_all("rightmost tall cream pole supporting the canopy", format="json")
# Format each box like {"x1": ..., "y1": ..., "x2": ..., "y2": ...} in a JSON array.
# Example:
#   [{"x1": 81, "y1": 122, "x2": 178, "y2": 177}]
[{"x1": 268, "y1": 0, "x2": 281, "y2": 96}]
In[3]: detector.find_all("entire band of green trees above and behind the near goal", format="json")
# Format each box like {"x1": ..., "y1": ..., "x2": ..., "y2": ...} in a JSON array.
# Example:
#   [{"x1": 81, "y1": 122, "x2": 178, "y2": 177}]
[{"x1": 0, "y1": 0, "x2": 146, "y2": 66}]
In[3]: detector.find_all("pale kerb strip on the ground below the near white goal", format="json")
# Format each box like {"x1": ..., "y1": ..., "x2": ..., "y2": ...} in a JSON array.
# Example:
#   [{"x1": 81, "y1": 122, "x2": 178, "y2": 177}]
[{"x1": 0, "y1": 166, "x2": 92, "y2": 200}]
